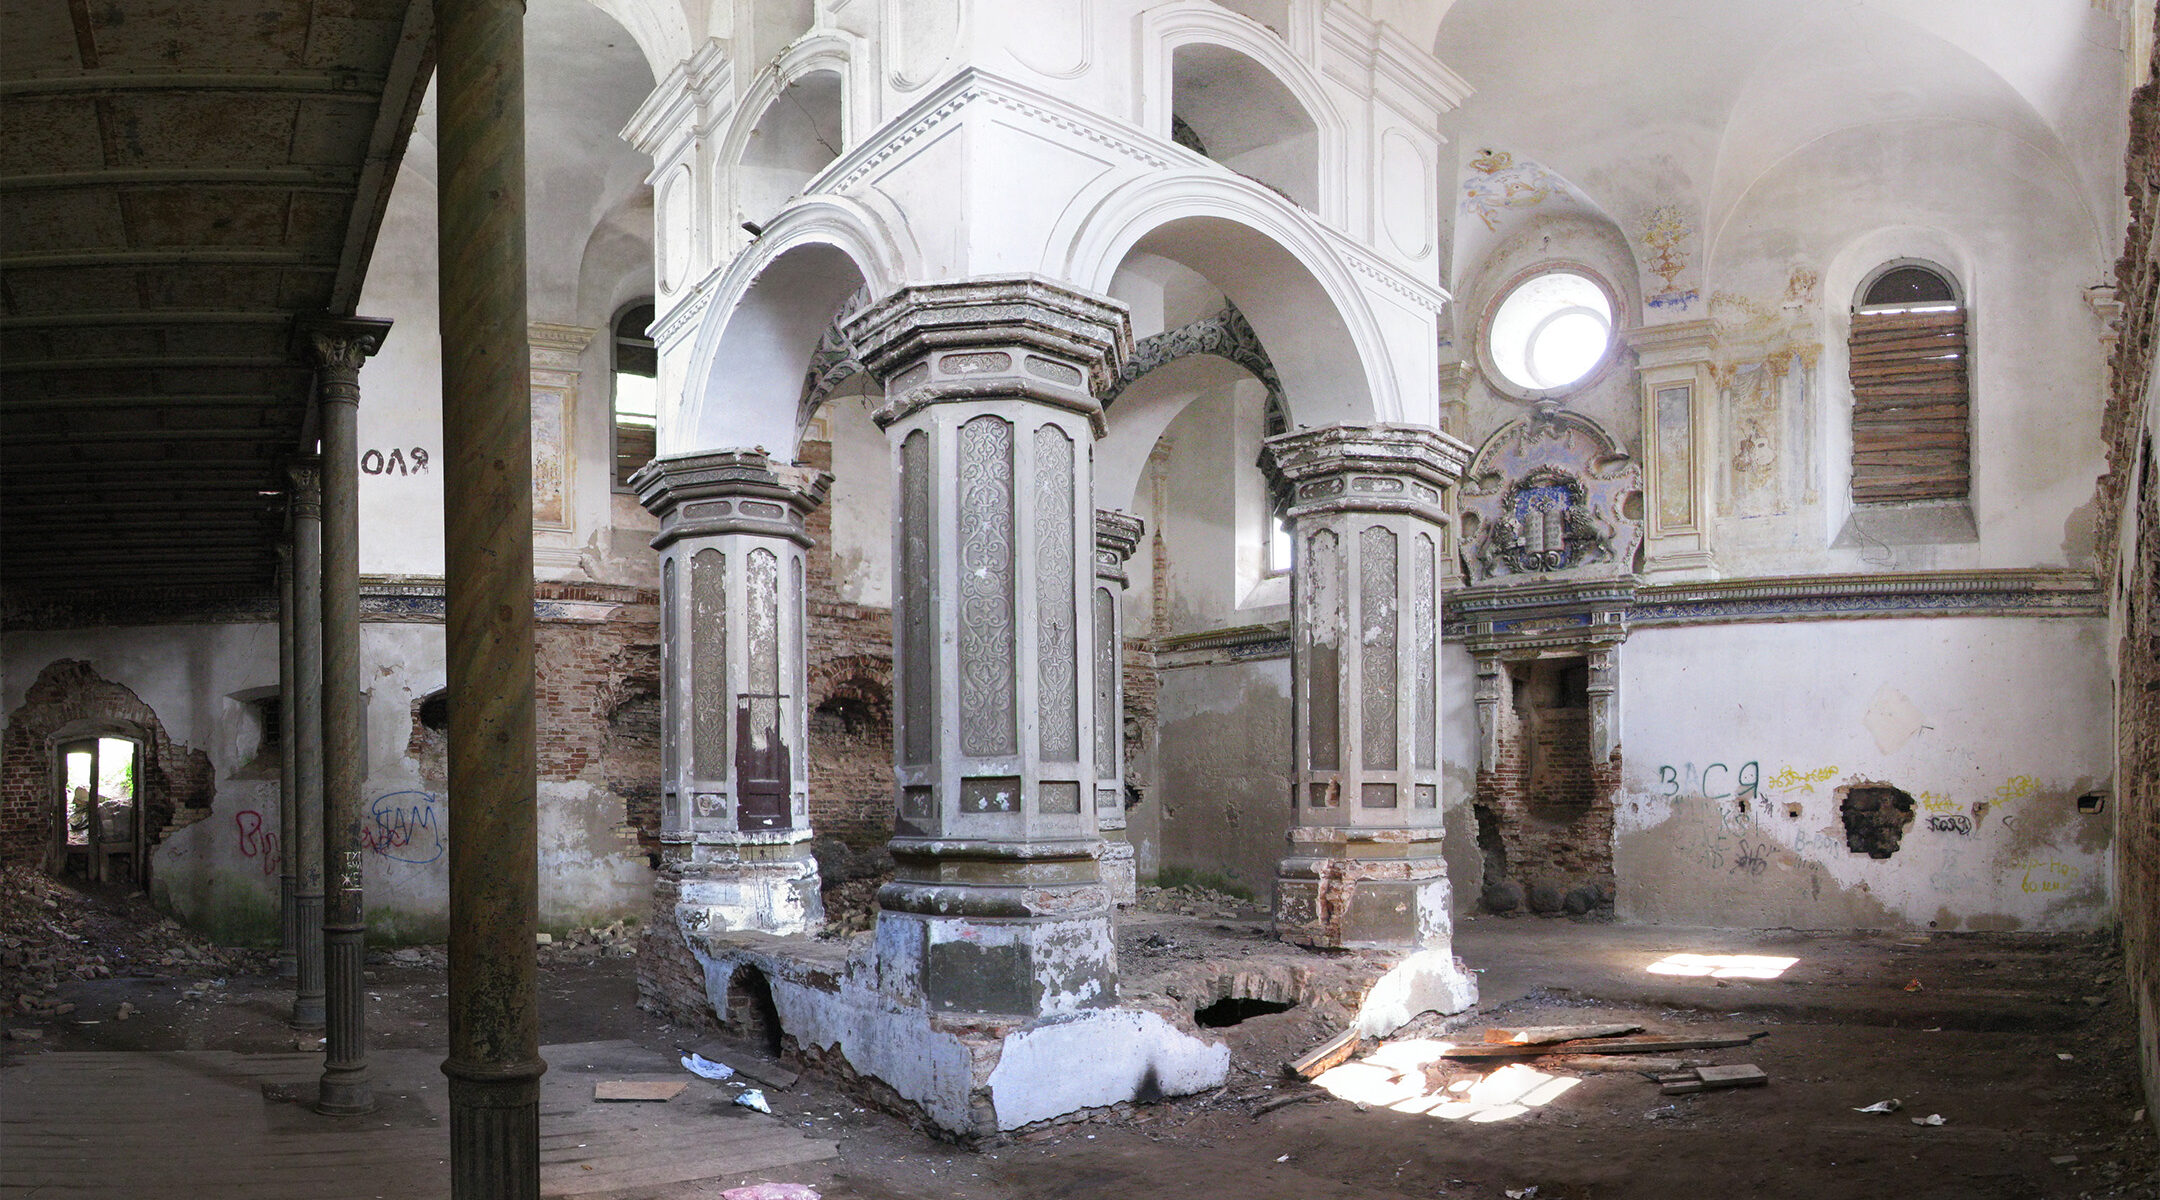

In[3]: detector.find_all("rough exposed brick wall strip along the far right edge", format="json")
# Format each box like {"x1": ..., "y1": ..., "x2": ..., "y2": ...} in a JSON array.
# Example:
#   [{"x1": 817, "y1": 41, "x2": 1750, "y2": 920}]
[{"x1": 2100, "y1": 16, "x2": 2160, "y2": 1129}]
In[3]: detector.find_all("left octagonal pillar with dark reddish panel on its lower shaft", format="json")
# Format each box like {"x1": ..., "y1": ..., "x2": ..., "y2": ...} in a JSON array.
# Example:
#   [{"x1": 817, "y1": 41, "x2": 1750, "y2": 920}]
[{"x1": 631, "y1": 451, "x2": 832, "y2": 935}]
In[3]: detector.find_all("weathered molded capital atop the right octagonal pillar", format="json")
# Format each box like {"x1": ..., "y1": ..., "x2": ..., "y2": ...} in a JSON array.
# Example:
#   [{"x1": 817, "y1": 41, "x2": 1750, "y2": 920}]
[{"x1": 1259, "y1": 425, "x2": 1471, "y2": 522}]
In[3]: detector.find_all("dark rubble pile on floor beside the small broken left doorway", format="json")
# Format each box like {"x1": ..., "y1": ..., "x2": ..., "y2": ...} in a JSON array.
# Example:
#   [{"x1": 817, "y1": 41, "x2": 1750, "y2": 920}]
[{"x1": 0, "y1": 865, "x2": 272, "y2": 1017}]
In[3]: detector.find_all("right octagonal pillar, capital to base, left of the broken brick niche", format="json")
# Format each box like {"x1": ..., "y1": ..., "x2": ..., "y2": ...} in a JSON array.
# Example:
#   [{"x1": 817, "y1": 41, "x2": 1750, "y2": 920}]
[{"x1": 1264, "y1": 425, "x2": 1469, "y2": 971}]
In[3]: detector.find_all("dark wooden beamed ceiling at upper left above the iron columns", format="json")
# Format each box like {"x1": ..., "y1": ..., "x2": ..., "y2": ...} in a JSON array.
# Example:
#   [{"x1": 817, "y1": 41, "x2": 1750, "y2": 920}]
[{"x1": 0, "y1": 0, "x2": 432, "y2": 602}]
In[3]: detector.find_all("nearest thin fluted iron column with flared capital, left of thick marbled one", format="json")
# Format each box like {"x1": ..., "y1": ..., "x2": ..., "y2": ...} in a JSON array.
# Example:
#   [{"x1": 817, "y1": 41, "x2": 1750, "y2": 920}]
[{"x1": 309, "y1": 317, "x2": 391, "y2": 1116}]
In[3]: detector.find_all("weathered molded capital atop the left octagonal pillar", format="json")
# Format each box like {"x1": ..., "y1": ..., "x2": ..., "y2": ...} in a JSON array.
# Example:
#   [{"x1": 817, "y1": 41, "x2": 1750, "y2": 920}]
[{"x1": 631, "y1": 449, "x2": 832, "y2": 550}]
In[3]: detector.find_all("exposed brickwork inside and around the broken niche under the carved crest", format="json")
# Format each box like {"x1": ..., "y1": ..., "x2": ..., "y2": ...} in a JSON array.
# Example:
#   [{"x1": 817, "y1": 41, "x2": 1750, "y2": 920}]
[{"x1": 1473, "y1": 658, "x2": 1620, "y2": 889}]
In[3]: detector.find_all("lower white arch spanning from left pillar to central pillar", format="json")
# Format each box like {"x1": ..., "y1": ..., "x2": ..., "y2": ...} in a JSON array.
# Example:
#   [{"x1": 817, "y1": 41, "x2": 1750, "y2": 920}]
[{"x1": 659, "y1": 194, "x2": 907, "y2": 460}]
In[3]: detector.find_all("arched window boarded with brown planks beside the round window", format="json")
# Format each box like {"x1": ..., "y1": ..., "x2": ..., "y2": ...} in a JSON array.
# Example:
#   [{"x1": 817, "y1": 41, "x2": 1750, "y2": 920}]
[{"x1": 1851, "y1": 265, "x2": 1972, "y2": 503}]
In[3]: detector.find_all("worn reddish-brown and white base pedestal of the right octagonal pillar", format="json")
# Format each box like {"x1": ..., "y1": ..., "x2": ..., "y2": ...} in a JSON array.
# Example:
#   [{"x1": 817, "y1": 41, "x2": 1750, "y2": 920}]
[{"x1": 1274, "y1": 829, "x2": 1454, "y2": 950}]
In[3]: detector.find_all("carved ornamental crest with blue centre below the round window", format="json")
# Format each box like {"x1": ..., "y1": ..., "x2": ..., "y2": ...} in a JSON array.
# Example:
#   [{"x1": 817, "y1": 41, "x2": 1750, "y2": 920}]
[{"x1": 1462, "y1": 401, "x2": 1642, "y2": 583}]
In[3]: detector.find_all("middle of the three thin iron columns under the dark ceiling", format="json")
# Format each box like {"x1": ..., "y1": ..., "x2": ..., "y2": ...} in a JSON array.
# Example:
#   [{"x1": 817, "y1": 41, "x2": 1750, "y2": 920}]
[{"x1": 285, "y1": 462, "x2": 322, "y2": 1029}]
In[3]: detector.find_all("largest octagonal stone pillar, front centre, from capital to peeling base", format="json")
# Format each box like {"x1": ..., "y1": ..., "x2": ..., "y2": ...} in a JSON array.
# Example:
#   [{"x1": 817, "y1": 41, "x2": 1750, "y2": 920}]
[{"x1": 845, "y1": 278, "x2": 1132, "y2": 1014}]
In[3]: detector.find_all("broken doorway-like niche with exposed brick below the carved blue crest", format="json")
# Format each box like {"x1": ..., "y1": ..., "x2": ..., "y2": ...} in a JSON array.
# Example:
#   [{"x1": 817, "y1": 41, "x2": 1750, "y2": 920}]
[{"x1": 1475, "y1": 656, "x2": 1618, "y2": 913}]
